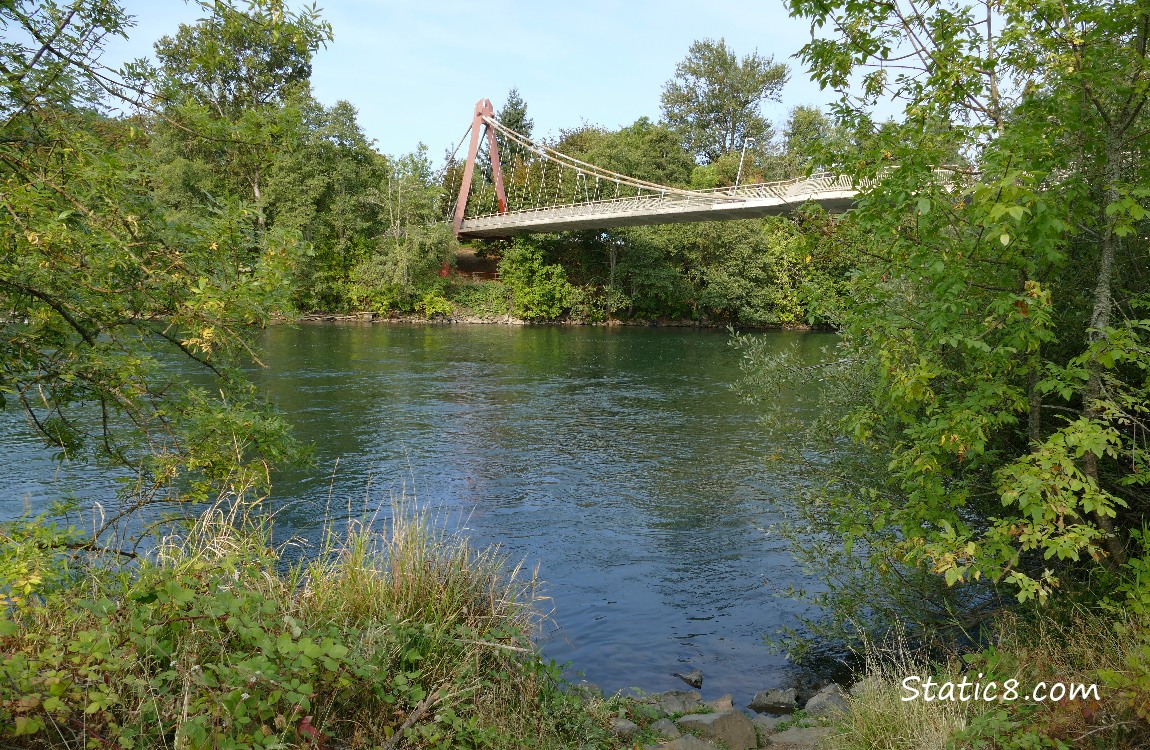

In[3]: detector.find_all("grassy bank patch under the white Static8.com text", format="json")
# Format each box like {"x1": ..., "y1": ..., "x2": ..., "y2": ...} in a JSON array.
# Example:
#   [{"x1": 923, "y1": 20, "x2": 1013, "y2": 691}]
[{"x1": 829, "y1": 607, "x2": 1150, "y2": 750}]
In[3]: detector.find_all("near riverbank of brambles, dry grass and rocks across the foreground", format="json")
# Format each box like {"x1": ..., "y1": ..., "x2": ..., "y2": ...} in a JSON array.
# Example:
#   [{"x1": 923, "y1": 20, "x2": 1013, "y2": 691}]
[{"x1": 0, "y1": 494, "x2": 1144, "y2": 750}]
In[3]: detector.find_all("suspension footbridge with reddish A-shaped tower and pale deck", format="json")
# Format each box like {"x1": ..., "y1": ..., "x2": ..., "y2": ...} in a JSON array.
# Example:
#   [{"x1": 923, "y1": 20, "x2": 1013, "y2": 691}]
[{"x1": 447, "y1": 99, "x2": 861, "y2": 239}]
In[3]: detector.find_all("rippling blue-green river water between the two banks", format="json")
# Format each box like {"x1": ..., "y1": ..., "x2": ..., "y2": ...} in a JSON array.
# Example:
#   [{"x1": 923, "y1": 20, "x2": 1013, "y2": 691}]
[{"x1": 0, "y1": 324, "x2": 834, "y2": 703}]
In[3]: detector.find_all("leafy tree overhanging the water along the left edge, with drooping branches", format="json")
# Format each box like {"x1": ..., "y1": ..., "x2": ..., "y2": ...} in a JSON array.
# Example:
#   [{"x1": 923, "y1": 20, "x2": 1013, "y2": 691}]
[{"x1": 0, "y1": 0, "x2": 299, "y2": 537}]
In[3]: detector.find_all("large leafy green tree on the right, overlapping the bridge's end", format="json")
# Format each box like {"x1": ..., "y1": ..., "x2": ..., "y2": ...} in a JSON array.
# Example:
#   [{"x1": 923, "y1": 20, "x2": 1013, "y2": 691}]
[{"x1": 768, "y1": 0, "x2": 1150, "y2": 621}]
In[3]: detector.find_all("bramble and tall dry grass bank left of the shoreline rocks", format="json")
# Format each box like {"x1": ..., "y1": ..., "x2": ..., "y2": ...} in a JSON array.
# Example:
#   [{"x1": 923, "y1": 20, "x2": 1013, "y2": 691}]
[{"x1": 0, "y1": 501, "x2": 625, "y2": 749}]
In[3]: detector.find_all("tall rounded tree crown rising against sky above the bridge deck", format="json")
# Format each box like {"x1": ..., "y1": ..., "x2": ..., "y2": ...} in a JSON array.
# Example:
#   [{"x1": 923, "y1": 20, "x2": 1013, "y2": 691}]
[{"x1": 661, "y1": 39, "x2": 788, "y2": 163}]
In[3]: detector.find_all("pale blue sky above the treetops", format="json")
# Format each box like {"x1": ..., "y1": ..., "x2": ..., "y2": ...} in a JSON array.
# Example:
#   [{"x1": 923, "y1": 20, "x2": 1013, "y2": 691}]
[{"x1": 104, "y1": 0, "x2": 834, "y2": 160}]
